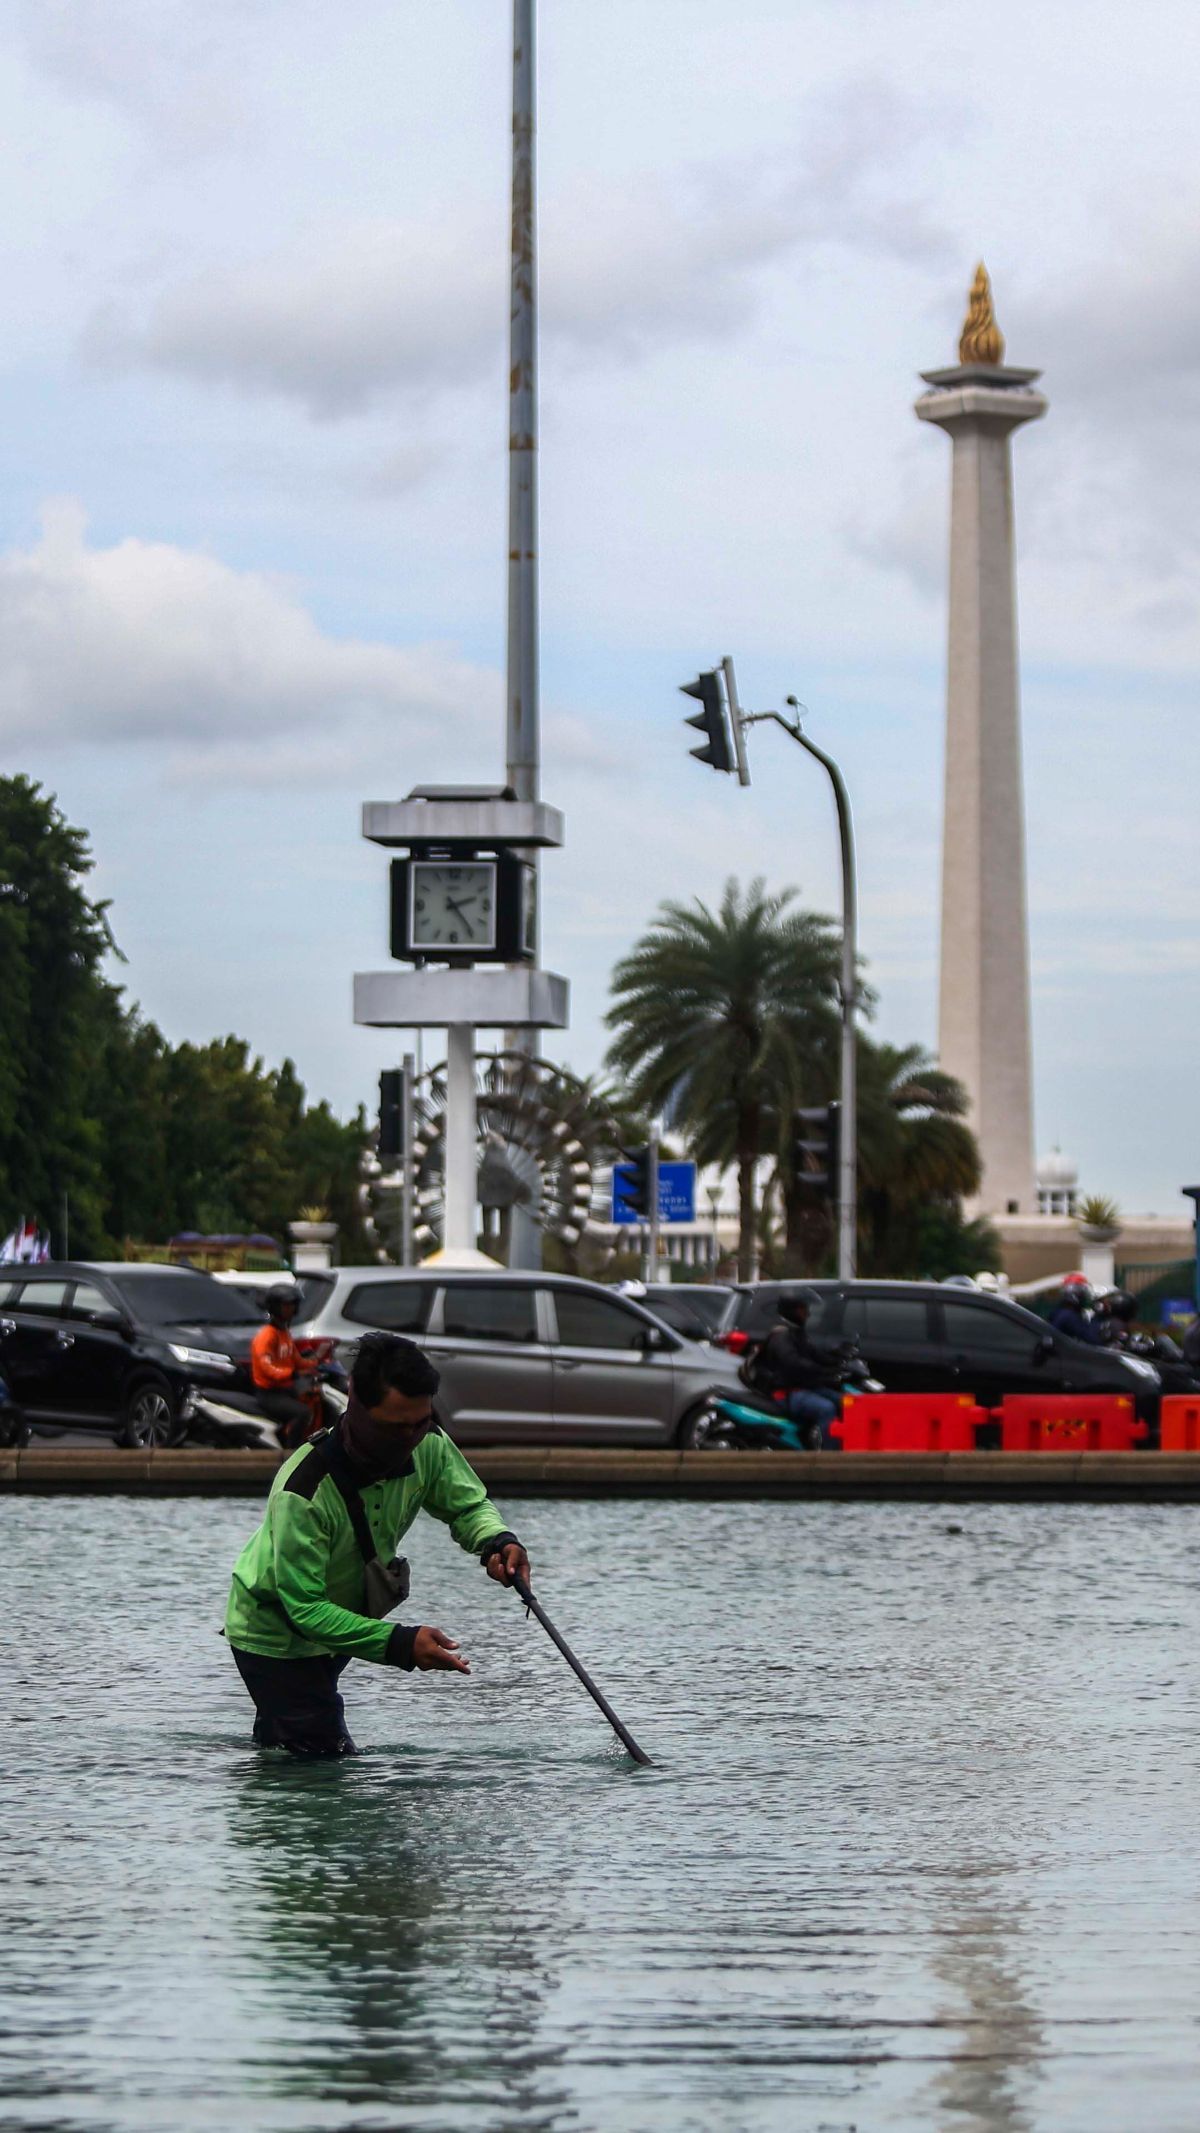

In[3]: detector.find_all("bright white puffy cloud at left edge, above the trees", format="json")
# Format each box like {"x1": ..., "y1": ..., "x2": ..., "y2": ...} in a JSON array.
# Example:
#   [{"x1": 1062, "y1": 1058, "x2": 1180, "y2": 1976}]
[{"x1": 0, "y1": 501, "x2": 499, "y2": 779}]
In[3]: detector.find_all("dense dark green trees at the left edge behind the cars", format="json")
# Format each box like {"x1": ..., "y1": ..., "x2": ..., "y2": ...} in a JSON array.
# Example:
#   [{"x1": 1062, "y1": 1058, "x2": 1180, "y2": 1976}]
[{"x1": 0, "y1": 779, "x2": 364, "y2": 1256}]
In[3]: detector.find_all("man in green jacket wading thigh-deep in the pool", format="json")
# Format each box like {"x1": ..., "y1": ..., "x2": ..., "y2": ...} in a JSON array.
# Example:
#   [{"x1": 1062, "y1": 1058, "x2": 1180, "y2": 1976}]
[{"x1": 226, "y1": 1333, "x2": 529, "y2": 1755}]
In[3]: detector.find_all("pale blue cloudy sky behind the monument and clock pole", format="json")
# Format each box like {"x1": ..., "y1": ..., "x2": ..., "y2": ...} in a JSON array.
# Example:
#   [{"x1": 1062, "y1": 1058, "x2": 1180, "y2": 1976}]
[{"x1": 0, "y1": 0, "x2": 1200, "y2": 1212}]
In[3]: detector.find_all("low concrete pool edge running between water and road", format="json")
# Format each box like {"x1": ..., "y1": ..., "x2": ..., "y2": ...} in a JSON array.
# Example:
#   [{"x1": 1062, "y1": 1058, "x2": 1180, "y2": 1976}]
[{"x1": 0, "y1": 1444, "x2": 1200, "y2": 1504}]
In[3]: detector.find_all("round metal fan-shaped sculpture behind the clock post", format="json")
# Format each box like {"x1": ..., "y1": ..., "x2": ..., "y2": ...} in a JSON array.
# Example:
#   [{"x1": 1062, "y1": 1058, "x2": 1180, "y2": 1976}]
[{"x1": 413, "y1": 1052, "x2": 618, "y2": 1256}]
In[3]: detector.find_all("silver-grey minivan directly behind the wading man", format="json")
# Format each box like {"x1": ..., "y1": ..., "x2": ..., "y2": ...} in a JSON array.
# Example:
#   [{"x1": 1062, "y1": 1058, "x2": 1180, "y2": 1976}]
[{"x1": 294, "y1": 1267, "x2": 737, "y2": 1444}]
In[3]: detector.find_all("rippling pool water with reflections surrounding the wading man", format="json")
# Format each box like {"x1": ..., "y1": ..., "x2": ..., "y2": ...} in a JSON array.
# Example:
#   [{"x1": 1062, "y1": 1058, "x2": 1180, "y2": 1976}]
[{"x1": 0, "y1": 1499, "x2": 1200, "y2": 2133}]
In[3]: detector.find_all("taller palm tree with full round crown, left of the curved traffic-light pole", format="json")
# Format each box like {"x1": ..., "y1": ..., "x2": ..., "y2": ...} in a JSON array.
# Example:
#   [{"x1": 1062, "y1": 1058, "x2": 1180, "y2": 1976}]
[{"x1": 605, "y1": 881, "x2": 840, "y2": 1280}]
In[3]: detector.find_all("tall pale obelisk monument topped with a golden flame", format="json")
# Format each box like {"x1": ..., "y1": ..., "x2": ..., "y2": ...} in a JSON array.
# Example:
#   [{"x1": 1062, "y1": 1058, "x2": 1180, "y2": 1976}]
[{"x1": 917, "y1": 267, "x2": 1047, "y2": 1214}]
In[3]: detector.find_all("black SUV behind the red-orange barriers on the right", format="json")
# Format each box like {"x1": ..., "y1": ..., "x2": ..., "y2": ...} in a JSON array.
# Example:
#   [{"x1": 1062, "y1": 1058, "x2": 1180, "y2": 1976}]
[{"x1": 711, "y1": 1280, "x2": 1160, "y2": 1416}]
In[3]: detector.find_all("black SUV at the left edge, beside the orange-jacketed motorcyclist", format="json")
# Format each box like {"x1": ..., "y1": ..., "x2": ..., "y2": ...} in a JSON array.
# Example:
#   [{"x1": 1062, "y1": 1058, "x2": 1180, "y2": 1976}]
[{"x1": 0, "y1": 1261, "x2": 262, "y2": 1446}]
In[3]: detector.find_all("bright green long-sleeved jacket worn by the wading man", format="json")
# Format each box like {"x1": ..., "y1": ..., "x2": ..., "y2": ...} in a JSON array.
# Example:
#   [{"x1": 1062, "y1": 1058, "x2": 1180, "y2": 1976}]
[{"x1": 226, "y1": 1429, "x2": 514, "y2": 1666}]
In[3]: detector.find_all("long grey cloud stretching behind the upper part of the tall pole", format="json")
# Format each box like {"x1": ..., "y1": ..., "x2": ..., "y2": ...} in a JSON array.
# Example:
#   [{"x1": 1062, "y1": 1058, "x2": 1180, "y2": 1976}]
[{"x1": 85, "y1": 79, "x2": 955, "y2": 420}]
